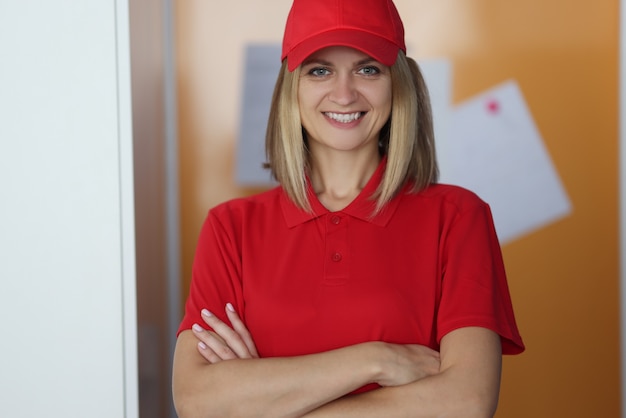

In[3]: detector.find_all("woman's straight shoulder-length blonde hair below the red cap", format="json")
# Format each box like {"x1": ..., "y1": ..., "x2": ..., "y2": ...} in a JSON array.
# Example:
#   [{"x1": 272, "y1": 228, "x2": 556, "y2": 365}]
[{"x1": 265, "y1": 51, "x2": 439, "y2": 213}]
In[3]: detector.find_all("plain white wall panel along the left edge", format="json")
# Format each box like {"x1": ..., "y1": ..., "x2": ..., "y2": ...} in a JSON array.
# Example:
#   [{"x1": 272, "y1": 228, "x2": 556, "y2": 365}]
[{"x1": 0, "y1": 0, "x2": 138, "y2": 418}]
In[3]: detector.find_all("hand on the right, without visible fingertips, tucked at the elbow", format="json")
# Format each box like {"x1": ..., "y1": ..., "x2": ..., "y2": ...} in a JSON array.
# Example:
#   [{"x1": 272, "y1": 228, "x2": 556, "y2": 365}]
[{"x1": 376, "y1": 343, "x2": 441, "y2": 386}]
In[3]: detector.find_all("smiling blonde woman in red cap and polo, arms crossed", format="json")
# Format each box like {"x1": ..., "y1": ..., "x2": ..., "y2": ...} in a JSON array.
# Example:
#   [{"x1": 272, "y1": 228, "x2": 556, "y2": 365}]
[{"x1": 173, "y1": 0, "x2": 524, "y2": 418}]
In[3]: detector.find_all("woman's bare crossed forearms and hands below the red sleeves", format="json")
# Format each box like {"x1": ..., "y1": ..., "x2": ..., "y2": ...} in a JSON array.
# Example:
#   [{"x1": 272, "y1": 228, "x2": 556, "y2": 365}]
[{"x1": 173, "y1": 307, "x2": 501, "y2": 418}]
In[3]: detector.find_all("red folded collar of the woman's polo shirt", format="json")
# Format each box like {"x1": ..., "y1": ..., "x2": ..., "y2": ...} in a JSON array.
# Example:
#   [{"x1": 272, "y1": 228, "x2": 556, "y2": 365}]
[{"x1": 280, "y1": 157, "x2": 402, "y2": 228}]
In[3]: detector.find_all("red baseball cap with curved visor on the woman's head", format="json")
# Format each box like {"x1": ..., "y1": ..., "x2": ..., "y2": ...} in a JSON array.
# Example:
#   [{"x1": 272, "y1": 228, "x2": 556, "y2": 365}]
[{"x1": 281, "y1": 0, "x2": 406, "y2": 71}]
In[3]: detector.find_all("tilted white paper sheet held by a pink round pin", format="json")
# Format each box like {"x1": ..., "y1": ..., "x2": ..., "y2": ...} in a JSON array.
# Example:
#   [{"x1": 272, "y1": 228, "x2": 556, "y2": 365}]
[{"x1": 437, "y1": 81, "x2": 571, "y2": 243}]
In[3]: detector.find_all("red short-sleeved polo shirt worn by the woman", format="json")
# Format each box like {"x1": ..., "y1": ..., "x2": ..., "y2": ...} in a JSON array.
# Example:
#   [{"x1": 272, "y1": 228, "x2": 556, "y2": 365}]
[{"x1": 179, "y1": 163, "x2": 524, "y2": 357}]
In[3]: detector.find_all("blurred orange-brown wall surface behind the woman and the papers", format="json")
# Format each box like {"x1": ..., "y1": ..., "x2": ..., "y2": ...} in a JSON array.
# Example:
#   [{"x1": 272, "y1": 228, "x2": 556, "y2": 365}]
[{"x1": 176, "y1": 0, "x2": 620, "y2": 418}]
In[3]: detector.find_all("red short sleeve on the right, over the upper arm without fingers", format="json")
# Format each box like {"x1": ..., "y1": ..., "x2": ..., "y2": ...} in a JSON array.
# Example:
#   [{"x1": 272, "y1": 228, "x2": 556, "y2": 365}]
[{"x1": 437, "y1": 198, "x2": 525, "y2": 354}]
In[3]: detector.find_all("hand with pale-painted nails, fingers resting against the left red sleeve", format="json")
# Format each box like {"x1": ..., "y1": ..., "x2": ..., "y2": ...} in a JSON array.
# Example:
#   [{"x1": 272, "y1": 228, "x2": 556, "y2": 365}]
[{"x1": 192, "y1": 303, "x2": 259, "y2": 364}]
